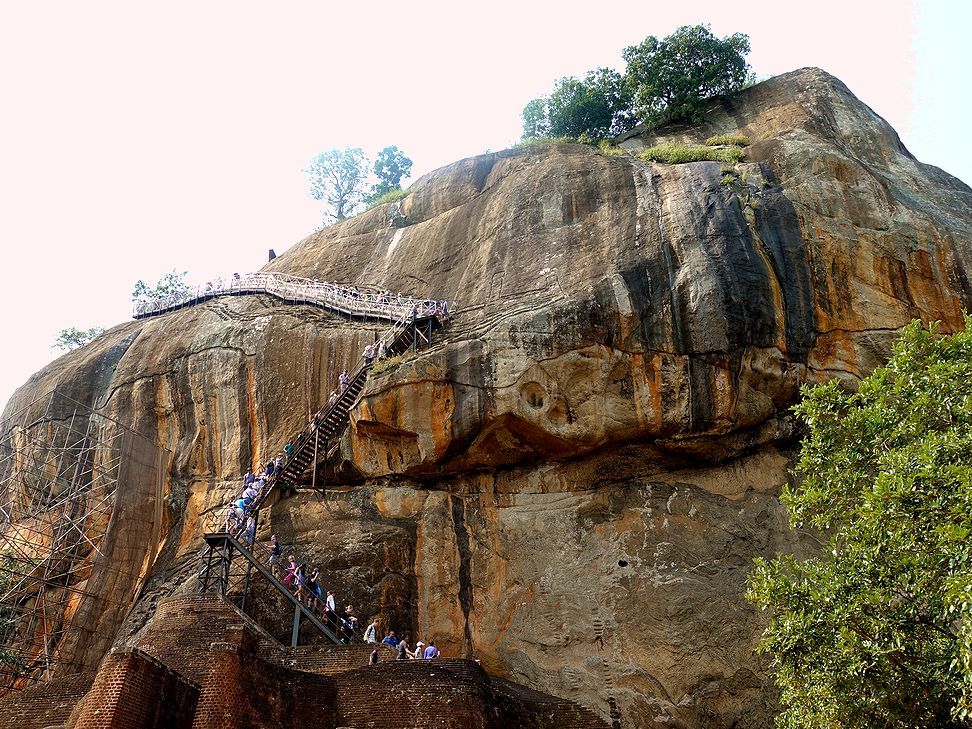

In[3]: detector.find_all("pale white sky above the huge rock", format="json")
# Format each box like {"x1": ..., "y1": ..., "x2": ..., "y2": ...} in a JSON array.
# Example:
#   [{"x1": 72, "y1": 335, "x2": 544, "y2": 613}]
[{"x1": 0, "y1": 0, "x2": 972, "y2": 410}]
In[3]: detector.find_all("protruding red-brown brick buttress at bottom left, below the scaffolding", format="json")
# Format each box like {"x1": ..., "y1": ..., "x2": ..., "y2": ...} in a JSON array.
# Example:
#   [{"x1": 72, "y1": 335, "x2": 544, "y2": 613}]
[{"x1": 70, "y1": 648, "x2": 199, "y2": 729}]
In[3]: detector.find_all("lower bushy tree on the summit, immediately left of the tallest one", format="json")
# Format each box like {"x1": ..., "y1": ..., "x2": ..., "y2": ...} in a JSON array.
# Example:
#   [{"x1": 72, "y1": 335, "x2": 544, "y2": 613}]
[{"x1": 522, "y1": 68, "x2": 634, "y2": 142}]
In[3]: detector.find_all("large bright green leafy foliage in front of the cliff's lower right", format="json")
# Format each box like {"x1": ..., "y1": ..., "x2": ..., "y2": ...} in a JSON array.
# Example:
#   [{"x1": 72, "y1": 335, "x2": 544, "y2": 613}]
[{"x1": 747, "y1": 317, "x2": 972, "y2": 727}]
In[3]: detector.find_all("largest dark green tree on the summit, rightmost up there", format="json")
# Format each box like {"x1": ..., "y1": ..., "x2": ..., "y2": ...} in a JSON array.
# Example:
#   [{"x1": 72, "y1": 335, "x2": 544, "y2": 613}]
[{"x1": 622, "y1": 25, "x2": 749, "y2": 127}]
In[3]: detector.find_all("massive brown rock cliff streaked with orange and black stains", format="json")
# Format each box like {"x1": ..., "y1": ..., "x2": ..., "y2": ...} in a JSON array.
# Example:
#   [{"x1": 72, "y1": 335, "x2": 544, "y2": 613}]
[{"x1": 1, "y1": 69, "x2": 972, "y2": 727}]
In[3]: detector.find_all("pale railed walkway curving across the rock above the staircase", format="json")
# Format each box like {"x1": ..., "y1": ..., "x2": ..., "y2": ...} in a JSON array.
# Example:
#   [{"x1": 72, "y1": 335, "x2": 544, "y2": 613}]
[{"x1": 132, "y1": 272, "x2": 449, "y2": 321}]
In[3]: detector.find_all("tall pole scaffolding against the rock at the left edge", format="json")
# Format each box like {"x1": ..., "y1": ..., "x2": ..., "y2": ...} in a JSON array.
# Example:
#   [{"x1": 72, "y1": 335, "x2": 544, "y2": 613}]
[{"x1": 0, "y1": 389, "x2": 165, "y2": 695}]
